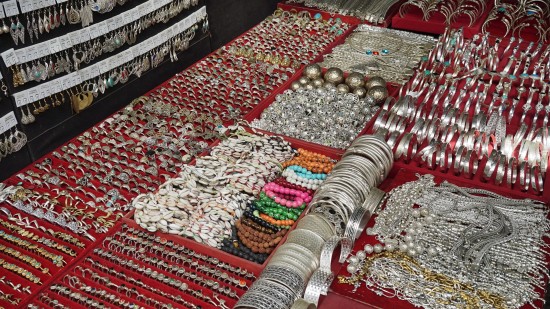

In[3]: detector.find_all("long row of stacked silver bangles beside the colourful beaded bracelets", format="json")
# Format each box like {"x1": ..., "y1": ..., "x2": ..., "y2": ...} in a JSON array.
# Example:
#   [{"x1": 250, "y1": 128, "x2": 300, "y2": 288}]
[{"x1": 239, "y1": 136, "x2": 393, "y2": 308}]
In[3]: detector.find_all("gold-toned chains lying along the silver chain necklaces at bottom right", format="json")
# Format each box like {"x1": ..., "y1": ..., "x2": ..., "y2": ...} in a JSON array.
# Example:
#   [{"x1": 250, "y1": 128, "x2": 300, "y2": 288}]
[{"x1": 338, "y1": 251, "x2": 507, "y2": 309}]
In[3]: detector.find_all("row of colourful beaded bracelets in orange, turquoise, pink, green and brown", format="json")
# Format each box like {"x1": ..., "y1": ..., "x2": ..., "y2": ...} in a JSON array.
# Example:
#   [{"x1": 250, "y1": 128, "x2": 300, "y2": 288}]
[{"x1": 222, "y1": 149, "x2": 334, "y2": 263}]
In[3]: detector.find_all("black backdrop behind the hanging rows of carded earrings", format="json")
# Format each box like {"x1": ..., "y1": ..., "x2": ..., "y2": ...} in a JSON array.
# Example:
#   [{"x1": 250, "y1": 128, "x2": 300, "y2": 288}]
[{"x1": 0, "y1": 0, "x2": 278, "y2": 181}]
